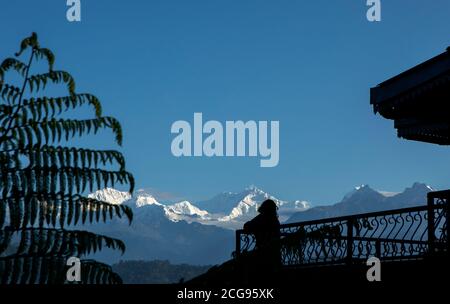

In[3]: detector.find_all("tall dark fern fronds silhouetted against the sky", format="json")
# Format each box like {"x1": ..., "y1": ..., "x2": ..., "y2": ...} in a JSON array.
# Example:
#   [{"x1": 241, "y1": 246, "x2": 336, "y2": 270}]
[{"x1": 0, "y1": 33, "x2": 134, "y2": 284}]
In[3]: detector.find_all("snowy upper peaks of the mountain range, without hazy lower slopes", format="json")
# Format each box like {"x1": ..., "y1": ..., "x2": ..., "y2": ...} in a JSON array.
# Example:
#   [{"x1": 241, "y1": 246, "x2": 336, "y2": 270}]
[{"x1": 89, "y1": 183, "x2": 433, "y2": 229}]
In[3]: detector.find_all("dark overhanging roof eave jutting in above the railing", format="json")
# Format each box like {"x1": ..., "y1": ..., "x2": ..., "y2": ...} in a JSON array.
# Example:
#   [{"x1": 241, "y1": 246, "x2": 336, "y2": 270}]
[{"x1": 370, "y1": 47, "x2": 450, "y2": 145}]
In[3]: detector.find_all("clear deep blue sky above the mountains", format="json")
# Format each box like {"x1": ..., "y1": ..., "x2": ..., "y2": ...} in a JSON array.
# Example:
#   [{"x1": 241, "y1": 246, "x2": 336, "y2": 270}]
[{"x1": 0, "y1": 0, "x2": 450, "y2": 204}]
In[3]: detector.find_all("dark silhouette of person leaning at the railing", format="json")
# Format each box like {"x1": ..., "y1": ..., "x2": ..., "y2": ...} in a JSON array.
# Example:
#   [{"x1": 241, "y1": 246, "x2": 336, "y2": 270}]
[{"x1": 244, "y1": 199, "x2": 281, "y2": 268}]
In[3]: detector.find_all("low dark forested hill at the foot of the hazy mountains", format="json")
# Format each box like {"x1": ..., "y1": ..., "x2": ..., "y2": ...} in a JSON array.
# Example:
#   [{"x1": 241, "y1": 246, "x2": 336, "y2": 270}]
[{"x1": 112, "y1": 260, "x2": 211, "y2": 284}]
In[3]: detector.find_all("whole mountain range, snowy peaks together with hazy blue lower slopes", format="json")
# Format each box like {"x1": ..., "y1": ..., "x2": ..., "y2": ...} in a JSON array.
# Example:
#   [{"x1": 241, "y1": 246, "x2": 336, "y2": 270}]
[{"x1": 90, "y1": 183, "x2": 432, "y2": 265}]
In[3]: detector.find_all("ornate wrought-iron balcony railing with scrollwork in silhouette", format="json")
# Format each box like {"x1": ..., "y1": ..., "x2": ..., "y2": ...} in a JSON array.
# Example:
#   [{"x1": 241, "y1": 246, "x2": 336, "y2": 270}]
[{"x1": 236, "y1": 190, "x2": 450, "y2": 266}]
